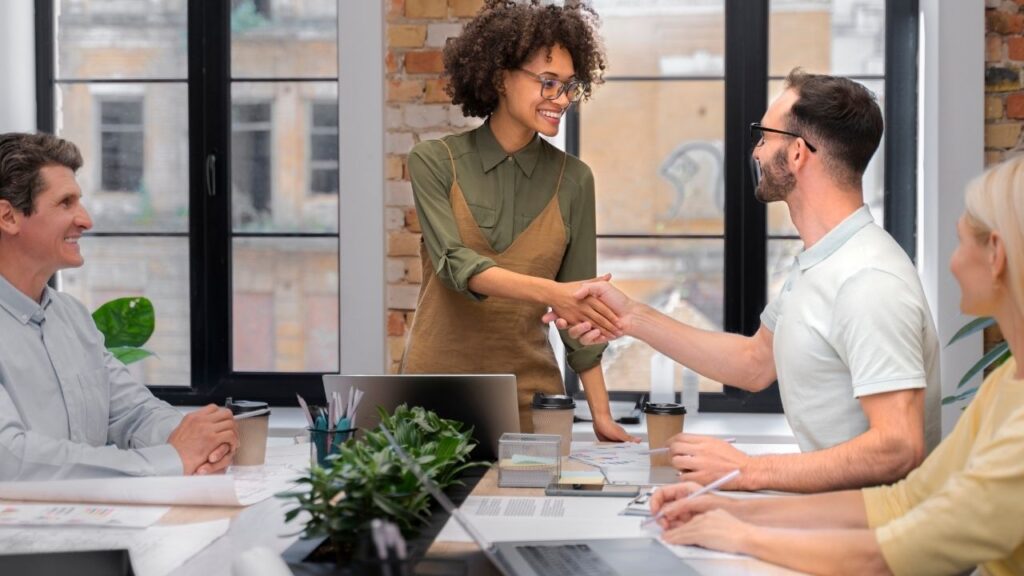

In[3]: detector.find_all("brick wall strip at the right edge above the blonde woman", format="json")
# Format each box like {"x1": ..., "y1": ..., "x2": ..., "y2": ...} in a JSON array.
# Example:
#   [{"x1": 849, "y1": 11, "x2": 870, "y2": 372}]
[{"x1": 984, "y1": 0, "x2": 1011, "y2": 352}]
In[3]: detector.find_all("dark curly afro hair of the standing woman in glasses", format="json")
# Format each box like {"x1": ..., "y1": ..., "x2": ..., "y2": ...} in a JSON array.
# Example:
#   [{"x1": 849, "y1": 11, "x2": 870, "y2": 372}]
[{"x1": 444, "y1": 0, "x2": 606, "y2": 118}]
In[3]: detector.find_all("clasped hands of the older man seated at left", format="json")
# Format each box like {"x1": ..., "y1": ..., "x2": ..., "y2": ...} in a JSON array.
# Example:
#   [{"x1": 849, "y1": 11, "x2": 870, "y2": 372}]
[{"x1": 167, "y1": 404, "x2": 239, "y2": 476}]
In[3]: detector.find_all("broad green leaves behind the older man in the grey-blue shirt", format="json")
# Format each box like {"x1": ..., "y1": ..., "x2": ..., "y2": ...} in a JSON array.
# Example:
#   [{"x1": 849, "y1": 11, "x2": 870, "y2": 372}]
[{"x1": 92, "y1": 296, "x2": 157, "y2": 364}]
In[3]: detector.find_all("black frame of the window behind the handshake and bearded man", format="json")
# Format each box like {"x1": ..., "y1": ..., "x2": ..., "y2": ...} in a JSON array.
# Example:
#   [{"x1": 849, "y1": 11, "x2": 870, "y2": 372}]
[{"x1": 565, "y1": 0, "x2": 920, "y2": 413}]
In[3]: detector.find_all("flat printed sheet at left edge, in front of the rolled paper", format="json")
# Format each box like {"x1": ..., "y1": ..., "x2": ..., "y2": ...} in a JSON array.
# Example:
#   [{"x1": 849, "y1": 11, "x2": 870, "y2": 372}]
[{"x1": 0, "y1": 504, "x2": 171, "y2": 528}]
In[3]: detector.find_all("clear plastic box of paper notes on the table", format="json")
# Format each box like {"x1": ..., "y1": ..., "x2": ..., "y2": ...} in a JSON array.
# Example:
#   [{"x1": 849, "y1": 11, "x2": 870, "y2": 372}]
[{"x1": 498, "y1": 433, "x2": 562, "y2": 488}]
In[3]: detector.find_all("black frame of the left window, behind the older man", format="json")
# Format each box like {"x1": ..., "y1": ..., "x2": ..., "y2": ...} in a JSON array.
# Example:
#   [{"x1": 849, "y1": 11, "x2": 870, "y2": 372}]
[{"x1": 35, "y1": 0, "x2": 339, "y2": 406}]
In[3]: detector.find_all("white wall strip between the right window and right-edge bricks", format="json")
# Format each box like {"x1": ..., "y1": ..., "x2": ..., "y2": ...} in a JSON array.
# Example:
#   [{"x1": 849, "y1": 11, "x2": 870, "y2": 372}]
[{"x1": 918, "y1": 0, "x2": 985, "y2": 435}]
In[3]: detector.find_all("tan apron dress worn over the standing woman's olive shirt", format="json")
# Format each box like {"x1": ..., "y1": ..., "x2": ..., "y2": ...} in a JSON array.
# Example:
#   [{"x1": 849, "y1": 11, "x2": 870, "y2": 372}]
[{"x1": 401, "y1": 140, "x2": 565, "y2": 433}]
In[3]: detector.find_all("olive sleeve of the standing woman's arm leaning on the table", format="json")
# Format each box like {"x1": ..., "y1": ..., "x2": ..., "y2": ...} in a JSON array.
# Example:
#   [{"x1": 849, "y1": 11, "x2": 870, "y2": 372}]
[{"x1": 555, "y1": 163, "x2": 607, "y2": 373}]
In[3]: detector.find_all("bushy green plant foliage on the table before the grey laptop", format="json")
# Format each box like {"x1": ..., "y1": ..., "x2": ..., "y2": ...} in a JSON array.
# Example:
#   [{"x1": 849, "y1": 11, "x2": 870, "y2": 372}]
[{"x1": 280, "y1": 405, "x2": 485, "y2": 564}]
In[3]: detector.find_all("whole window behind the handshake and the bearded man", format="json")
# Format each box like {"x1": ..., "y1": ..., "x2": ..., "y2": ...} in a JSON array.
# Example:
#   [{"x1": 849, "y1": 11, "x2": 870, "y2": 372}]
[{"x1": 566, "y1": 0, "x2": 916, "y2": 411}]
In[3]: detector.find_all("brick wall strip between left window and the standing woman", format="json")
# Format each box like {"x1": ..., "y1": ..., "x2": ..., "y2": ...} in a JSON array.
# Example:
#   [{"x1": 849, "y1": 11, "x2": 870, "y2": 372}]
[{"x1": 384, "y1": 0, "x2": 482, "y2": 372}]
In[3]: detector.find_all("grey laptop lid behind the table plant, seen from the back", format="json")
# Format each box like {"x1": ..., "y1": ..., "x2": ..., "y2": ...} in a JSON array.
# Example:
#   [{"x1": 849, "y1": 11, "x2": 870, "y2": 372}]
[{"x1": 324, "y1": 374, "x2": 519, "y2": 461}]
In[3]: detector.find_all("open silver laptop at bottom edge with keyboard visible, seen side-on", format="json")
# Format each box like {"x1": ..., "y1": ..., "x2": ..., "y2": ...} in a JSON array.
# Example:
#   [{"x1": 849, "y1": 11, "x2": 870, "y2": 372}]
[{"x1": 380, "y1": 428, "x2": 698, "y2": 576}]
